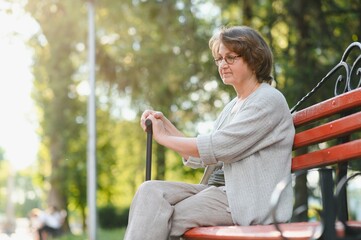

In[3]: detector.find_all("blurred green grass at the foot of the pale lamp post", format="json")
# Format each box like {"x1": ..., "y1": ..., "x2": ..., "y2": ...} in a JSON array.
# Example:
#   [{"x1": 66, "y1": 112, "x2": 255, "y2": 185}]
[{"x1": 56, "y1": 228, "x2": 125, "y2": 240}]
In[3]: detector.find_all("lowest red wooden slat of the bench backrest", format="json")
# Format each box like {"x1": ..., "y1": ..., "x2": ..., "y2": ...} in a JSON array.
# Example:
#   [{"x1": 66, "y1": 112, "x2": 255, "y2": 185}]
[{"x1": 292, "y1": 139, "x2": 361, "y2": 171}]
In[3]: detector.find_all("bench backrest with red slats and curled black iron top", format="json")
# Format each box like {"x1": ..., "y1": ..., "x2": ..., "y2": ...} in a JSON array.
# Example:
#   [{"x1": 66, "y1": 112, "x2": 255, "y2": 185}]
[{"x1": 291, "y1": 42, "x2": 361, "y2": 172}]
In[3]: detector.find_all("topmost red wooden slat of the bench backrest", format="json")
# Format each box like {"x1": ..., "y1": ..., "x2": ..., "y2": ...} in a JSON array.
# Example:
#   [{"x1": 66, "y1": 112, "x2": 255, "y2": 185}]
[{"x1": 293, "y1": 88, "x2": 361, "y2": 127}]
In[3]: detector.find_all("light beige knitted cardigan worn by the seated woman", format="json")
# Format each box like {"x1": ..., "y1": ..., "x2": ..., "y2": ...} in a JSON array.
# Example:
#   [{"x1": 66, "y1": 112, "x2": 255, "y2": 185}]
[{"x1": 184, "y1": 83, "x2": 295, "y2": 225}]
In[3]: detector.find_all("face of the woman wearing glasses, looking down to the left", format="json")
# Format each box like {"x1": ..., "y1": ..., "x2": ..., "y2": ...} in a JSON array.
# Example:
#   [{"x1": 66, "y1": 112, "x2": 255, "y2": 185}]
[{"x1": 218, "y1": 43, "x2": 255, "y2": 89}]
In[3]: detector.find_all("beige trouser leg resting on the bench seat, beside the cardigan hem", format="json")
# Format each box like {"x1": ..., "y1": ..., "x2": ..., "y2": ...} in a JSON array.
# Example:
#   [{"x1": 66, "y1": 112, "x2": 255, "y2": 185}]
[{"x1": 170, "y1": 186, "x2": 233, "y2": 237}]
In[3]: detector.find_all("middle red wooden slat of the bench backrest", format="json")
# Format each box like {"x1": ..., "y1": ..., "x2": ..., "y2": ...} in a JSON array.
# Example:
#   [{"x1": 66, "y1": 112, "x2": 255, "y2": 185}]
[{"x1": 293, "y1": 112, "x2": 361, "y2": 149}]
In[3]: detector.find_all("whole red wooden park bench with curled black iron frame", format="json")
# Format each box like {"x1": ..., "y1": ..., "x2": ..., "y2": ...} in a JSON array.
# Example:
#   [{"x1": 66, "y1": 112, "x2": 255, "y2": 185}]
[{"x1": 183, "y1": 42, "x2": 361, "y2": 240}]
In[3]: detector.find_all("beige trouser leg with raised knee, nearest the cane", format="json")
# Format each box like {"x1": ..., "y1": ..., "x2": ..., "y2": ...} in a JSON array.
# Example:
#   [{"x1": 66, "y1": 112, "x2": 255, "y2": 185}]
[{"x1": 124, "y1": 181, "x2": 207, "y2": 240}]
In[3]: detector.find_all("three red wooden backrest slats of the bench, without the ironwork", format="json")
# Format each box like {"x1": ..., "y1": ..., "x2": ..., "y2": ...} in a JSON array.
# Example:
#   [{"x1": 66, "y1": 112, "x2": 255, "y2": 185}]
[{"x1": 292, "y1": 88, "x2": 361, "y2": 171}]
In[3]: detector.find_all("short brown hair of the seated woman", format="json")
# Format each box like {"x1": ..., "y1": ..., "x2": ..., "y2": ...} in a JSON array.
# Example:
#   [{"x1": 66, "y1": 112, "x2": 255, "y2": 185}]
[{"x1": 209, "y1": 26, "x2": 273, "y2": 83}]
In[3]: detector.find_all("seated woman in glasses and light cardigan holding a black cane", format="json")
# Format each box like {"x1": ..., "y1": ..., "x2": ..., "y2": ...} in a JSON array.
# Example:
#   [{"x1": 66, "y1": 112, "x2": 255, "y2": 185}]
[{"x1": 125, "y1": 26, "x2": 294, "y2": 240}]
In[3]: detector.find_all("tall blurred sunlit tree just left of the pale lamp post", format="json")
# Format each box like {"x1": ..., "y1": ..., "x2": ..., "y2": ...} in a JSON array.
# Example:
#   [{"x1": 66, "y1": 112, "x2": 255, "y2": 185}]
[{"x1": 27, "y1": 0, "x2": 85, "y2": 231}]
